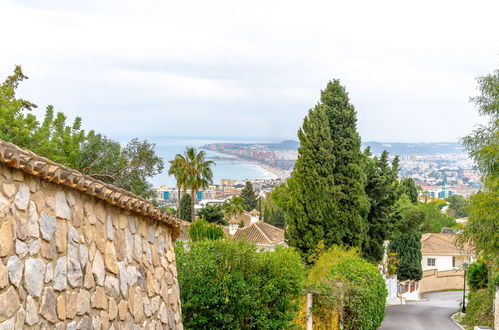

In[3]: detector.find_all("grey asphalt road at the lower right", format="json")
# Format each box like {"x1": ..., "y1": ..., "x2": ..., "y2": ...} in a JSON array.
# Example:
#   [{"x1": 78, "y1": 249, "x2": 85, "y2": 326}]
[{"x1": 379, "y1": 291, "x2": 463, "y2": 330}]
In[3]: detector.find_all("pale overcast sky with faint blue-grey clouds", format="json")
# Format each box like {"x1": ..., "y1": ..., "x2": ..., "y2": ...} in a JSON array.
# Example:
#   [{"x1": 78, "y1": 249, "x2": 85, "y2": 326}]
[{"x1": 0, "y1": 0, "x2": 499, "y2": 142}]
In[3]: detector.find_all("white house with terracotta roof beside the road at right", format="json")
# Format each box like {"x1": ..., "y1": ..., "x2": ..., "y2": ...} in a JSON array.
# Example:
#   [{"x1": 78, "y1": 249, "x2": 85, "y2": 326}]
[{"x1": 421, "y1": 233, "x2": 471, "y2": 271}]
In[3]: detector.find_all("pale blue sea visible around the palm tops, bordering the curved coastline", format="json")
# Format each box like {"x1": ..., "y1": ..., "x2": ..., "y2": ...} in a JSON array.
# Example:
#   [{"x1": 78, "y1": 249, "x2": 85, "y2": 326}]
[{"x1": 148, "y1": 137, "x2": 277, "y2": 187}]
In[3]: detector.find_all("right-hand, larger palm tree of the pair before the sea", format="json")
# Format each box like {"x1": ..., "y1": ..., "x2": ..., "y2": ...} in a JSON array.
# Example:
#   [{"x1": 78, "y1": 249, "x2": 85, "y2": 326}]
[{"x1": 184, "y1": 147, "x2": 215, "y2": 221}]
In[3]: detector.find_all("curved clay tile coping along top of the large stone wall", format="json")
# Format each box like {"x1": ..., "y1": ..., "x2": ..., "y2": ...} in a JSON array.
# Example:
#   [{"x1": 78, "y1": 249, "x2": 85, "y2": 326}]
[{"x1": 0, "y1": 139, "x2": 180, "y2": 241}]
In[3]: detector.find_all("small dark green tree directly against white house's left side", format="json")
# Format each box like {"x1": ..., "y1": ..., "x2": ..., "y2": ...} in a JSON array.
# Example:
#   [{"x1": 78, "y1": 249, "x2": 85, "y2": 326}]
[{"x1": 388, "y1": 233, "x2": 423, "y2": 281}]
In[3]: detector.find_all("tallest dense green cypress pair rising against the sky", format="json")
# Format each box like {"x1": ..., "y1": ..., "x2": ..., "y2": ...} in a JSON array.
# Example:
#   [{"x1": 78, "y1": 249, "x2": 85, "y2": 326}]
[{"x1": 284, "y1": 80, "x2": 369, "y2": 259}]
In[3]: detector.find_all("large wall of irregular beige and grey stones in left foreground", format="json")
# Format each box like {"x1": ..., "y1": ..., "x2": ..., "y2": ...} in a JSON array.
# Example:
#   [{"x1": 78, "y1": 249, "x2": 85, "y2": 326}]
[{"x1": 0, "y1": 164, "x2": 182, "y2": 330}]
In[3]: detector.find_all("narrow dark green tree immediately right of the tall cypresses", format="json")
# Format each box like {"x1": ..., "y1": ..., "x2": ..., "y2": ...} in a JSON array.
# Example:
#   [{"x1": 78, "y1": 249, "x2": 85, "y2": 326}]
[{"x1": 362, "y1": 148, "x2": 399, "y2": 263}]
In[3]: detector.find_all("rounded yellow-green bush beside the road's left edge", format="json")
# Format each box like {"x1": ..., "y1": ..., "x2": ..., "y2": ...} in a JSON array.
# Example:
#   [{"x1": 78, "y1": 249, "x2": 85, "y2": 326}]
[{"x1": 307, "y1": 246, "x2": 387, "y2": 329}]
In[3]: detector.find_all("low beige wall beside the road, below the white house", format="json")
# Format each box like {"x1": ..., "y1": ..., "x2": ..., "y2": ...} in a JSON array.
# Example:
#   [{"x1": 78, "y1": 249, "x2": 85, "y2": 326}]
[{"x1": 419, "y1": 269, "x2": 464, "y2": 293}]
